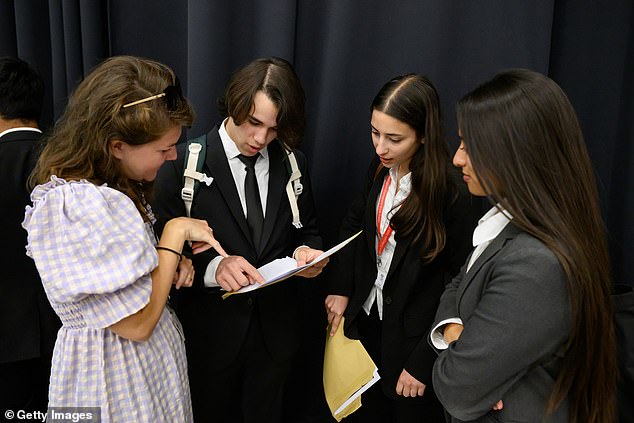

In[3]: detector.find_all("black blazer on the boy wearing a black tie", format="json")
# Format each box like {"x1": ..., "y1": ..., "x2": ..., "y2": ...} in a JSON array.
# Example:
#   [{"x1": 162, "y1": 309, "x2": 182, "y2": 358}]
[{"x1": 153, "y1": 126, "x2": 321, "y2": 368}]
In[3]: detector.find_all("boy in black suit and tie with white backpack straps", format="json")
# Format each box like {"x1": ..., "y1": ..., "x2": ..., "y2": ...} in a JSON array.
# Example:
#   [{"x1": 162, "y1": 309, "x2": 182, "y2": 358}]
[{"x1": 153, "y1": 57, "x2": 326, "y2": 423}]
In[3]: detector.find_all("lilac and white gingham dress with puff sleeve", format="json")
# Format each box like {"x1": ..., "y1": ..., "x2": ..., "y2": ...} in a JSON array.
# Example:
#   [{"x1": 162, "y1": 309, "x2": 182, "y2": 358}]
[{"x1": 23, "y1": 176, "x2": 193, "y2": 422}]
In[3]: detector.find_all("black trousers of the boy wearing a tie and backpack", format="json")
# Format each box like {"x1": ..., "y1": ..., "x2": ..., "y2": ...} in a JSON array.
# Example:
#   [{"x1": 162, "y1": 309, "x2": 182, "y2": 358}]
[{"x1": 189, "y1": 313, "x2": 291, "y2": 423}]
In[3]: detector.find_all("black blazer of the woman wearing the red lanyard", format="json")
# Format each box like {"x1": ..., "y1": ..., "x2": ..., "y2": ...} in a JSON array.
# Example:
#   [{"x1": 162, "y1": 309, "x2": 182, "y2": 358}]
[{"x1": 329, "y1": 158, "x2": 481, "y2": 400}]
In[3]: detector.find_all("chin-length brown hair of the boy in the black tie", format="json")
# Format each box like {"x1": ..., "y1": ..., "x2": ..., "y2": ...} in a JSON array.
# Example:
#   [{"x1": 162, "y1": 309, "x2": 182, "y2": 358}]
[{"x1": 218, "y1": 57, "x2": 306, "y2": 148}]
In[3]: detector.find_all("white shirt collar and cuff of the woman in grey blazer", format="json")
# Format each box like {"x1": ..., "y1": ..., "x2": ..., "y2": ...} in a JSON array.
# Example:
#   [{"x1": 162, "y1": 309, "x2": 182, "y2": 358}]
[{"x1": 430, "y1": 205, "x2": 513, "y2": 350}]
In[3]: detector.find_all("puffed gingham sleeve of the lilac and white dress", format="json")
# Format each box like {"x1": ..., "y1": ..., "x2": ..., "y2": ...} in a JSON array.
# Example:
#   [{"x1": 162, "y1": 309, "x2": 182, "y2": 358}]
[{"x1": 23, "y1": 177, "x2": 158, "y2": 328}]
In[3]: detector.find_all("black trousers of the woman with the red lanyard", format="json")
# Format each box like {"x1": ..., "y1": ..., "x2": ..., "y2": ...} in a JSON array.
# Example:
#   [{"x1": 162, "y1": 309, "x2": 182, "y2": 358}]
[{"x1": 344, "y1": 303, "x2": 445, "y2": 423}]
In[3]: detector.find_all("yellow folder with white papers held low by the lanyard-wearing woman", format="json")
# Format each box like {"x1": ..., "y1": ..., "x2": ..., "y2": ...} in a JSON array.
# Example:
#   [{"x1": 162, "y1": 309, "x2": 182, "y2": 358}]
[{"x1": 323, "y1": 318, "x2": 380, "y2": 422}]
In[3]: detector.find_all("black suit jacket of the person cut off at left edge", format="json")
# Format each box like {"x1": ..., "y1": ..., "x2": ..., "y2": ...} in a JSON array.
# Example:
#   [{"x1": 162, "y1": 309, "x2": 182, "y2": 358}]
[{"x1": 0, "y1": 131, "x2": 60, "y2": 363}]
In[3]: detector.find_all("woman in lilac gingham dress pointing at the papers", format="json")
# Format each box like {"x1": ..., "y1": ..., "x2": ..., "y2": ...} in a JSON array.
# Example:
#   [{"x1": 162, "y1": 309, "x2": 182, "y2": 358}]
[{"x1": 23, "y1": 56, "x2": 225, "y2": 422}]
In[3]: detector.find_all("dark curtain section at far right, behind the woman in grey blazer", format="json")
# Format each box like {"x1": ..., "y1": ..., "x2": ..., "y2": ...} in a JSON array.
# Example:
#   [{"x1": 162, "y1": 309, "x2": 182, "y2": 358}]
[{"x1": 548, "y1": 0, "x2": 634, "y2": 286}]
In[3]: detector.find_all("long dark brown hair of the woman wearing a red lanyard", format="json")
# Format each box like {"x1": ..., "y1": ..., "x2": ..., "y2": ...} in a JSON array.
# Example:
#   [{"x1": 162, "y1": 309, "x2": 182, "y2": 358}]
[{"x1": 371, "y1": 73, "x2": 454, "y2": 262}]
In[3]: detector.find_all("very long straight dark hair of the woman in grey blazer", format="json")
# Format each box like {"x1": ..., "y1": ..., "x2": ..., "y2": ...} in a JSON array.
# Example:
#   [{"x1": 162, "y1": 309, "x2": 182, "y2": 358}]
[{"x1": 457, "y1": 69, "x2": 617, "y2": 423}]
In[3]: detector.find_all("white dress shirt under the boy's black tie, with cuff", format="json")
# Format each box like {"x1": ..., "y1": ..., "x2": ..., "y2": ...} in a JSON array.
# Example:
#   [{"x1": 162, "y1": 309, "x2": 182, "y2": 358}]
[{"x1": 203, "y1": 119, "x2": 269, "y2": 288}]
